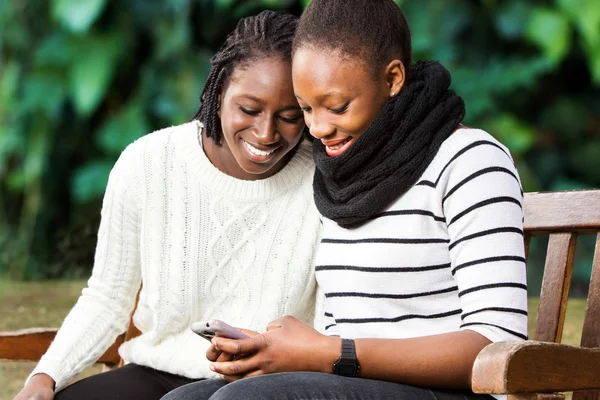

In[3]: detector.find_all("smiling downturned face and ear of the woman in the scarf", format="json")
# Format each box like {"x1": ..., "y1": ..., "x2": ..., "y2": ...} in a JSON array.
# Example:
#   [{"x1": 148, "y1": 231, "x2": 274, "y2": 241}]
[{"x1": 292, "y1": 47, "x2": 404, "y2": 157}]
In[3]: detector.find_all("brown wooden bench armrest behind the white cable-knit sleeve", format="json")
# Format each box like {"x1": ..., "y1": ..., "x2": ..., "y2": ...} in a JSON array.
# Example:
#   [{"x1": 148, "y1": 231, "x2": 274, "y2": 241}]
[{"x1": 0, "y1": 328, "x2": 124, "y2": 365}]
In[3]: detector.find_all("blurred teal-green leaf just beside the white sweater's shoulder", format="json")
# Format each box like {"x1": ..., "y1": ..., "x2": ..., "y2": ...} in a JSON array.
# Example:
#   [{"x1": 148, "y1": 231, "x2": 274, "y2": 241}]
[{"x1": 71, "y1": 161, "x2": 114, "y2": 204}]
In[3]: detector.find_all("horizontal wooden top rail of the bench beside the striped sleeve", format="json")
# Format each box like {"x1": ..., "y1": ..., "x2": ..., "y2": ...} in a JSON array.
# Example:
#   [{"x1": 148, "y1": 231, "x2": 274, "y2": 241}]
[{"x1": 525, "y1": 190, "x2": 600, "y2": 233}]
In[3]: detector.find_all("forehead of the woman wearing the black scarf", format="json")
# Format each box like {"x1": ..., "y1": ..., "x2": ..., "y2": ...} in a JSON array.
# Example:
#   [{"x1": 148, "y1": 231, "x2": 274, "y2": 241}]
[{"x1": 292, "y1": 47, "x2": 373, "y2": 94}]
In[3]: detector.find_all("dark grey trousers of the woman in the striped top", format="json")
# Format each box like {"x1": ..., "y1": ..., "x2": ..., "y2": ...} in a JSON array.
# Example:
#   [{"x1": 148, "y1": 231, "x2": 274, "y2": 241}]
[{"x1": 162, "y1": 372, "x2": 493, "y2": 400}]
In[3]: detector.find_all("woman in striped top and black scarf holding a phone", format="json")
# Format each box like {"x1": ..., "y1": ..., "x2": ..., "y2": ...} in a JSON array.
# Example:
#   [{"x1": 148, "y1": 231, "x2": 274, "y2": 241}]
[{"x1": 165, "y1": 0, "x2": 527, "y2": 400}]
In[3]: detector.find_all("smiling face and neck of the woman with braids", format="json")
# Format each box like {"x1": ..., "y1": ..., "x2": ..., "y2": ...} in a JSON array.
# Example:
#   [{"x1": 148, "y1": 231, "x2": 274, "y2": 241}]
[{"x1": 203, "y1": 58, "x2": 304, "y2": 180}]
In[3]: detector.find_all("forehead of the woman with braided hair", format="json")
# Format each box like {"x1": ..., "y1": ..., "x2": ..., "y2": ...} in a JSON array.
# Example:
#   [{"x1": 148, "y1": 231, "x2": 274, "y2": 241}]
[{"x1": 227, "y1": 57, "x2": 292, "y2": 97}]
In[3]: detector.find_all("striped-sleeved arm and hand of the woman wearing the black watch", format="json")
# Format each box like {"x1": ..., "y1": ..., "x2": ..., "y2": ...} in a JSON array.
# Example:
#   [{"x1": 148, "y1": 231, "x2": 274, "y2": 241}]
[{"x1": 210, "y1": 134, "x2": 527, "y2": 388}]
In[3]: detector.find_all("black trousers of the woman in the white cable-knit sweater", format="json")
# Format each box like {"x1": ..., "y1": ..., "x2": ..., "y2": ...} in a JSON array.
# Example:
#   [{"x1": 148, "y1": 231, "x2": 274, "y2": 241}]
[{"x1": 54, "y1": 364, "x2": 204, "y2": 400}]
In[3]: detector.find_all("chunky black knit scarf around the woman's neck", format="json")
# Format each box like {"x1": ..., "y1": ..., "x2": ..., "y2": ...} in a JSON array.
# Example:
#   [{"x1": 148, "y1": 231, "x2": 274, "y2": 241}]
[{"x1": 313, "y1": 61, "x2": 465, "y2": 228}]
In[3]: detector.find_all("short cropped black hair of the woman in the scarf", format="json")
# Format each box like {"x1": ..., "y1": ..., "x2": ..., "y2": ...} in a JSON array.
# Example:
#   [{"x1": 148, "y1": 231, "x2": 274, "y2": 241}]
[{"x1": 293, "y1": 0, "x2": 412, "y2": 73}]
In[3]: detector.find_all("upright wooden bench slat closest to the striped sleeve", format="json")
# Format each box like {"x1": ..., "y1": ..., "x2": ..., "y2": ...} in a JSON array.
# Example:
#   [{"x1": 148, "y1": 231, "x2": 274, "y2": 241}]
[{"x1": 535, "y1": 233, "x2": 577, "y2": 343}]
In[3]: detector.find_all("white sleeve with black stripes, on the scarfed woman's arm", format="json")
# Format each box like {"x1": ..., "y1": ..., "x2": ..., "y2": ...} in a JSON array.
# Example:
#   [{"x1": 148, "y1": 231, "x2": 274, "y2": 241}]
[{"x1": 442, "y1": 136, "x2": 527, "y2": 342}]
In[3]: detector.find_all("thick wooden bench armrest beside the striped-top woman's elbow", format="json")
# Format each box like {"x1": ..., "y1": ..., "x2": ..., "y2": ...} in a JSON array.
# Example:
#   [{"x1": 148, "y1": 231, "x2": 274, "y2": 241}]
[{"x1": 472, "y1": 340, "x2": 600, "y2": 394}]
